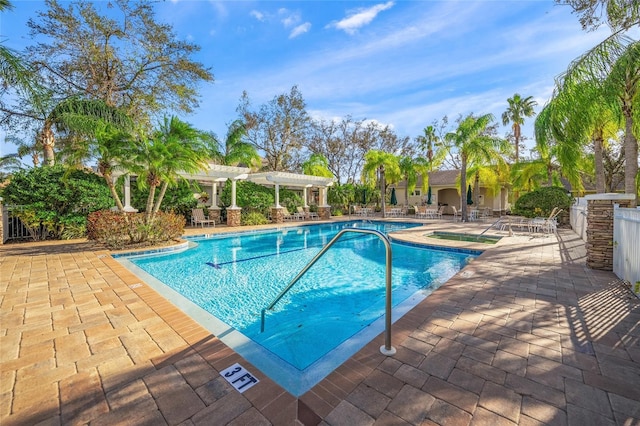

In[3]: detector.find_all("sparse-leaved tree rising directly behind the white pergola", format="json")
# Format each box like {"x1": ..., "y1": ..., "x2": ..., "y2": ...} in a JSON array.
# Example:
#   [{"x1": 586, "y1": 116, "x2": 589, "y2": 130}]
[{"x1": 238, "y1": 86, "x2": 309, "y2": 171}]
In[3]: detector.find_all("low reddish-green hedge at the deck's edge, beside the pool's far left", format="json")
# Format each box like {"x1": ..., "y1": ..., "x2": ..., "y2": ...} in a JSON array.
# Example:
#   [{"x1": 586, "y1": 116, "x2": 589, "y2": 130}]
[{"x1": 87, "y1": 210, "x2": 185, "y2": 249}]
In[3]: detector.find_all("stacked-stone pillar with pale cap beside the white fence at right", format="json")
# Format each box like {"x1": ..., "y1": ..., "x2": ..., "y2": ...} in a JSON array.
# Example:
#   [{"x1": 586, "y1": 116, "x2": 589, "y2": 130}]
[{"x1": 584, "y1": 194, "x2": 635, "y2": 271}]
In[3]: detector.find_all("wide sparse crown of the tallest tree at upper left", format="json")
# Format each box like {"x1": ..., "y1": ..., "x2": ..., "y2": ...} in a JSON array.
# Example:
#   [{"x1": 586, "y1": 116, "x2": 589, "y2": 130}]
[{"x1": 7, "y1": 0, "x2": 213, "y2": 129}]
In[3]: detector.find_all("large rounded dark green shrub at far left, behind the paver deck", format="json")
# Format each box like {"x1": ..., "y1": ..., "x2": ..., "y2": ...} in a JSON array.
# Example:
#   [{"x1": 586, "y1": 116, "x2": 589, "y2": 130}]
[{"x1": 2, "y1": 165, "x2": 114, "y2": 239}]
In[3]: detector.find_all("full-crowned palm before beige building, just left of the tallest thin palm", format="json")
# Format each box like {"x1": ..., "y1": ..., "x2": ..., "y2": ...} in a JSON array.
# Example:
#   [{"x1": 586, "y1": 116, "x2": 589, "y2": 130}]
[{"x1": 445, "y1": 114, "x2": 504, "y2": 221}]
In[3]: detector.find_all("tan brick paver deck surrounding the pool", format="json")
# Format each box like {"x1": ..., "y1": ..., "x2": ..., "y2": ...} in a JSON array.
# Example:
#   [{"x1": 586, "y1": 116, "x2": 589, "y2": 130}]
[{"x1": 0, "y1": 224, "x2": 640, "y2": 426}]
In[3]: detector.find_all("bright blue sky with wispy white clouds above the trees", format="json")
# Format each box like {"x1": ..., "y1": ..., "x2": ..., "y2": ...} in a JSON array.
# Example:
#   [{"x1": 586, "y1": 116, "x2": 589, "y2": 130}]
[{"x1": 0, "y1": 0, "x2": 608, "y2": 161}]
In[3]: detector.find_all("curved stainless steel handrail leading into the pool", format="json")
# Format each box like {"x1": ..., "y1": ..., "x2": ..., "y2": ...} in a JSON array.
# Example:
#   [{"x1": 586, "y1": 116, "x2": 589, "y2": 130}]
[{"x1": 260, "y1": 228, "x2": 396, "y2": 355}]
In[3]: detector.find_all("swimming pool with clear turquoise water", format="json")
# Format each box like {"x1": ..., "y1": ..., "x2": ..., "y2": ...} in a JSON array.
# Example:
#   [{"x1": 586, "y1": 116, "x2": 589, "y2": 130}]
[{"x1": 118, "y1": 221, "x2": 477, "y2": 395}]
